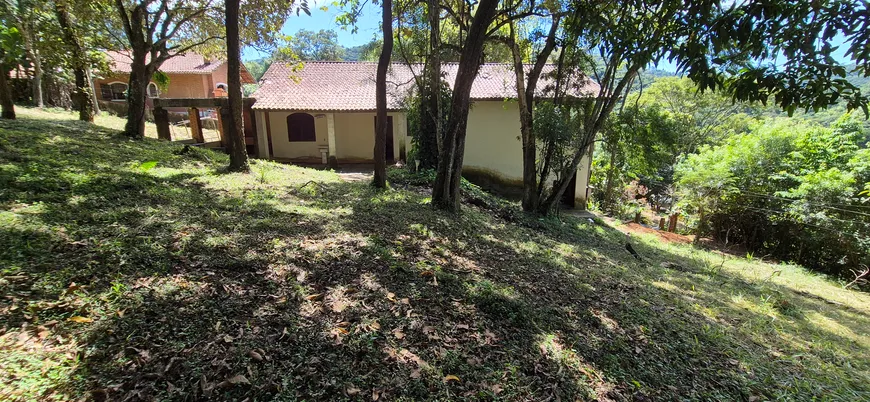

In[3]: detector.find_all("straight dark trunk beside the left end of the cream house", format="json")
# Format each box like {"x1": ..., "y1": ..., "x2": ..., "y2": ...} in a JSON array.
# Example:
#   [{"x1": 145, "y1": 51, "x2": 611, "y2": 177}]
[{"x1": 225, "y1": 0, "x2": 250, "y2": 172}]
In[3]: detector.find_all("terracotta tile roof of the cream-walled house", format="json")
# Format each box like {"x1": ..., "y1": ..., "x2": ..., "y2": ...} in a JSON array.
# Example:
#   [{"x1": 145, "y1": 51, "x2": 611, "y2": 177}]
[{"x1": 252, "y1": 61, "x2": 599, "y2": 111}]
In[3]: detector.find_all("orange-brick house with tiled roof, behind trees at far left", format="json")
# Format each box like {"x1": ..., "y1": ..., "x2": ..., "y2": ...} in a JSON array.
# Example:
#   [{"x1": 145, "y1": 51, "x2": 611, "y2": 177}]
[{"x1": 94, "y1": 51, "x2": 256, "y2": 107}]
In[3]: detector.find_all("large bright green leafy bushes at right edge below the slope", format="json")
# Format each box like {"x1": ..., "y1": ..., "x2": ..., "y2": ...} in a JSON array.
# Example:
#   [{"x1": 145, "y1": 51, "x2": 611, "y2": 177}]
[{"x1": 677, "y1": 116, "x2": 870, "y2": 274}]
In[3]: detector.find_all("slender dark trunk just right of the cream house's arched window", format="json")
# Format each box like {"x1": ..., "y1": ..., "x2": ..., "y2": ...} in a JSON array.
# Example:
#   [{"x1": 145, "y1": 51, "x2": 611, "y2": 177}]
[{"x1": 372, "y1": 0, "x2": 393, "y2": 188}]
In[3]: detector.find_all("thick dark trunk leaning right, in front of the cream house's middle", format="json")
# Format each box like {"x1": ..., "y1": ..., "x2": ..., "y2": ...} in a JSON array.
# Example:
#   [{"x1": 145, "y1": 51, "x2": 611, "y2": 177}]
[{"x1": 432, "y1": 0, "x2": 499, "y2": 212}]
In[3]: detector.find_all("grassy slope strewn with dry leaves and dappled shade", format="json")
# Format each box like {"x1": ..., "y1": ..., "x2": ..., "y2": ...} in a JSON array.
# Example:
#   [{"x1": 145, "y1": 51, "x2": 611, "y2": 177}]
[{"x1": 0, "y1": 109, "x2": 870, "y2": 401}]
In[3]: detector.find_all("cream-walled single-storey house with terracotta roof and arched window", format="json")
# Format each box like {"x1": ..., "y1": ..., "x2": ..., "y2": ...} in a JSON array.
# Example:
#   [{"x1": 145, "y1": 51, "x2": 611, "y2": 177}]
[{"x1": 252, "y1": 62, "x2": 598, "y2": 208}]
